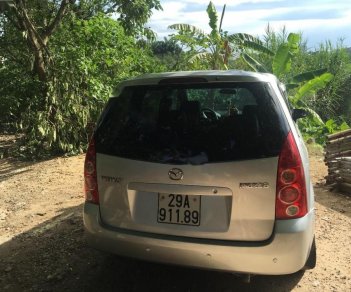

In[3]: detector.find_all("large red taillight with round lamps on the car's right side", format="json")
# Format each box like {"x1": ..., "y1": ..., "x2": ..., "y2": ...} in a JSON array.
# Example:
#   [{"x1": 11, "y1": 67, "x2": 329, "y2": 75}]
[{"x1": 275, "y1": 132, "x2": 307, "y2": 219}]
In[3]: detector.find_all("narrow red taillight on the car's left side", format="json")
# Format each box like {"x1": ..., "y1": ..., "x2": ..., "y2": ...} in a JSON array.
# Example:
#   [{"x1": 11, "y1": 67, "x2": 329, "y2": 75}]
[{"x1": 84, "y1": 139, "x2": 99, "y2": 204}]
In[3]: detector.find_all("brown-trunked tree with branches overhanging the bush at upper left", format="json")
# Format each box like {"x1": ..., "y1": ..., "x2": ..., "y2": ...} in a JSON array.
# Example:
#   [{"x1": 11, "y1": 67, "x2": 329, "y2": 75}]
[{"x1": 5, "y1": 0, "x2": 161, "y2": 82}]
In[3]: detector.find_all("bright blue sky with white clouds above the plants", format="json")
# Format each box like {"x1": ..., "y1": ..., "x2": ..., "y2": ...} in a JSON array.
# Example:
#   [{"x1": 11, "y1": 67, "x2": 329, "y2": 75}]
[{"x1": 148, "y1": 0, "x2": 351, "y2": 49}]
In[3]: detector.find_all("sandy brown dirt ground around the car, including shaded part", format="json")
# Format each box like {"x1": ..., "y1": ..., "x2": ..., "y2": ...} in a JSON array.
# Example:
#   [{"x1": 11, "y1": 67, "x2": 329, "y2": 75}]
[{"x1": 0, "y1": 136, "x2": 351, "y2": 292}]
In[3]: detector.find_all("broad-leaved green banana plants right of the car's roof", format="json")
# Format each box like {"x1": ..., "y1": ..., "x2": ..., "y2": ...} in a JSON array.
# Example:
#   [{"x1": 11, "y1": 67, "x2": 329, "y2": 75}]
[{"x1": 247, "y1": 26, "x2": 351, "y2": 143}]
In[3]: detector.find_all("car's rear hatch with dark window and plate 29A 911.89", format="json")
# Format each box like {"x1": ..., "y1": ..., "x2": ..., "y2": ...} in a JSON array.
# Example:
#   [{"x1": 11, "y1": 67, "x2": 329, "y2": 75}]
[{"x1": 95, "y1": 82, "x2": 288, "y2": 241}]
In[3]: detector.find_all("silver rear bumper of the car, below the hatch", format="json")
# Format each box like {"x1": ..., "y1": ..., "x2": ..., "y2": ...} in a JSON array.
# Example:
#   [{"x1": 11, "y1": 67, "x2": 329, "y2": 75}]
[{"x1": 84, "y1": 203, "x2": 314, "y2": 275}]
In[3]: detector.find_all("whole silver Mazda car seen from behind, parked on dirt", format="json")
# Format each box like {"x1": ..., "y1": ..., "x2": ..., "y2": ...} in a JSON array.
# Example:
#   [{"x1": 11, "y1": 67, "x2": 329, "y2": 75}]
[{"x1": 84, "y1": 71, "x2": 316, "y2": 275}]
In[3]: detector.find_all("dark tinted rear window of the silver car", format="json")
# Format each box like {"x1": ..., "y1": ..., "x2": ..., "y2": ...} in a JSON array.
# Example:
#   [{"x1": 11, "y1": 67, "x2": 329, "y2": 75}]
[{"x1": 95, "y1": 82, "x2": 287, "y2": 164}]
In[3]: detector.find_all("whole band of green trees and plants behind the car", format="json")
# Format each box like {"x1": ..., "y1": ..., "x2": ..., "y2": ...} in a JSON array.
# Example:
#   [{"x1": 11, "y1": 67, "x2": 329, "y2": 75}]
[{"x1": 0, "y1": 0, "x2": 351, "y2": 156}]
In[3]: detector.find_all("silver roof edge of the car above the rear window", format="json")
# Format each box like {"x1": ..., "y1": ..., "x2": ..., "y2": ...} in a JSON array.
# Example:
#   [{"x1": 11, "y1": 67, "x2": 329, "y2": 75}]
[{"x1": 120, "y1": 70, "x2": 279, "y2": 87}]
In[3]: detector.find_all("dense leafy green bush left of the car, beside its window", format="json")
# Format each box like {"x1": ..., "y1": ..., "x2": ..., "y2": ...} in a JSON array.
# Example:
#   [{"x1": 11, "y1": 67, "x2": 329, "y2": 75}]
[{"x1": 18, "y1": 14, "x2": 162, "y2": 154}]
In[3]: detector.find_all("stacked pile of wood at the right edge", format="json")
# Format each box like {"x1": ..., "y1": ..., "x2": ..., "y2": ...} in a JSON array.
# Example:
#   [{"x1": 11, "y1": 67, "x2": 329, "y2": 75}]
[{"x1": 324, "y1": 129, "x2": 351, "y2": 194}]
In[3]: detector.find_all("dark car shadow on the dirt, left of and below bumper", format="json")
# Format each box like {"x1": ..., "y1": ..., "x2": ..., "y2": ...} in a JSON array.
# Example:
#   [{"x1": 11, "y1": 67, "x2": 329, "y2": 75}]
[{"x1": 0, "y1": 205, "x2": 303, "y2": 292}]
